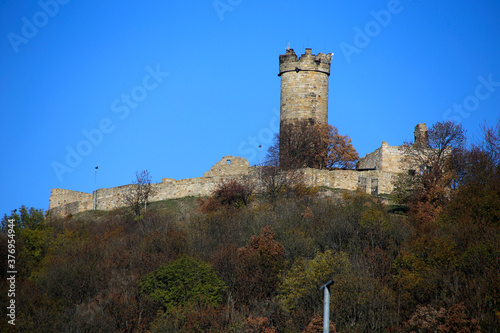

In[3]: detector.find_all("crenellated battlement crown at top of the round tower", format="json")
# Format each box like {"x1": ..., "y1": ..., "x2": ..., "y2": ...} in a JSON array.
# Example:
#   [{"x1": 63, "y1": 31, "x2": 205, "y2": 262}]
[{"x1": 278, "y1": 48, "x2": 332, "y2": 76}]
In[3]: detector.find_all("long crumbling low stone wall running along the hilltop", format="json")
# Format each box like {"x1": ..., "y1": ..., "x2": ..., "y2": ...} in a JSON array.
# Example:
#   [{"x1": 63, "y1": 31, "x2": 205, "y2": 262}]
[{"x1": 49, "y1": 156, "x2": 402, "y2": 216}]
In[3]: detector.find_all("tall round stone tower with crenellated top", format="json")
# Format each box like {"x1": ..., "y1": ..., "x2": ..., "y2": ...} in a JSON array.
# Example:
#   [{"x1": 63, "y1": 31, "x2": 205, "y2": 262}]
[{"x1": 278, "y1": 48, "x2": 332, "y2": 127}]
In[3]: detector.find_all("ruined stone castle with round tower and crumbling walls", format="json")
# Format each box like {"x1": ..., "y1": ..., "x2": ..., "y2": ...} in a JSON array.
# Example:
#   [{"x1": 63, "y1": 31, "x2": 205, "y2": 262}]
[{"x1": 49, "y1": 49, "x2": 428, "y2": 215}]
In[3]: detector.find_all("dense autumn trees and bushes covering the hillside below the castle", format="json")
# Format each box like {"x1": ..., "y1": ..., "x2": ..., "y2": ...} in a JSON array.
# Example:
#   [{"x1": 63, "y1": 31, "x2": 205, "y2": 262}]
[{"x1": 0, "y1": 120, "x2": 500, "y2": 333}]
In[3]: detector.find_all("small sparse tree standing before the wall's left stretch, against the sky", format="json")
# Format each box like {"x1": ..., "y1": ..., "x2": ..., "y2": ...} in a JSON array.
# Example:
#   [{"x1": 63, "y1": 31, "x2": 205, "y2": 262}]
[{"x1": 124, "y1": 170, "x2": 155, "y2": 220}]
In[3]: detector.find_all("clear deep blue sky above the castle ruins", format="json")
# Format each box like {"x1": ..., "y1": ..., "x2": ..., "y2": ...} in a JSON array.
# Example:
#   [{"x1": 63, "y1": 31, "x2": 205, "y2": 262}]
[{"x1": 0, "y1": 0, "x2": 500, "y2": 215}]
